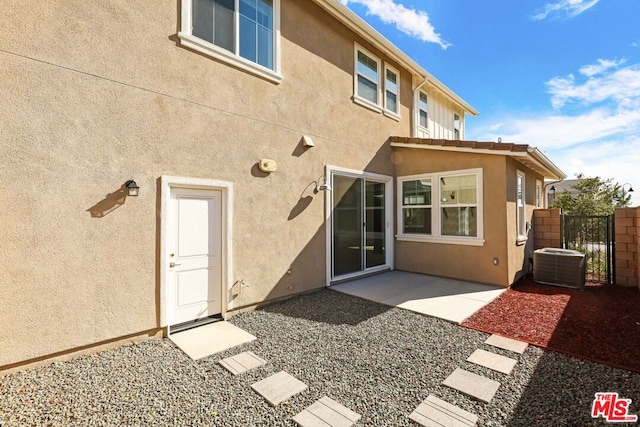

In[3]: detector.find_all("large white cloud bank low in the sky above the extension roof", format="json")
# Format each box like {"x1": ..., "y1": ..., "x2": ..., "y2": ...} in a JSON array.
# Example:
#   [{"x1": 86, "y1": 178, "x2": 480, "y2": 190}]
[{"x1": 467, "y1": 60, "x2": 640, "y2": 206}]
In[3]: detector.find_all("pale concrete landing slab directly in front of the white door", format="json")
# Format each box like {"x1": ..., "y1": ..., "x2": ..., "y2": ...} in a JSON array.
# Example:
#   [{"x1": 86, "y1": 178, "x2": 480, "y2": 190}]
[{"x1": 169, "y1": 322, "x2": 256, "y2": 360}]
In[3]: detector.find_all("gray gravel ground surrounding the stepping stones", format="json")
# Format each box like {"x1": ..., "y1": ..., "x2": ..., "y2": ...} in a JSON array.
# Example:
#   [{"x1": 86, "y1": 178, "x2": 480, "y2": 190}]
[{"x1": 0, "y1": 290, "x2": 640, "y2": 426}]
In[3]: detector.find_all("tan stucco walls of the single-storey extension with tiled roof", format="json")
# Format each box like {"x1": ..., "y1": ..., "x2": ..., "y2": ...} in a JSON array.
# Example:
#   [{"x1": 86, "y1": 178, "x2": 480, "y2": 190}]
[{"x1": 394, "y1": 148, "x2": 542, "y2": 287}]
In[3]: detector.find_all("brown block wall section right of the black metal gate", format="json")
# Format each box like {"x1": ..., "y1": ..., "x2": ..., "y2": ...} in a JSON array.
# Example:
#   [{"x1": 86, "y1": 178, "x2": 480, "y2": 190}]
[{"x1": 615, "y1": 207, "x2": 640, "y2": 289}]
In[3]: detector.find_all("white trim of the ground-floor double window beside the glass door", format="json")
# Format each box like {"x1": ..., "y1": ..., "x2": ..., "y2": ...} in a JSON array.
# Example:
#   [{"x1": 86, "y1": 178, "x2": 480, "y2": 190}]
[{"x1": 396, "y1": 168, "x2": 485, "y2": 246}]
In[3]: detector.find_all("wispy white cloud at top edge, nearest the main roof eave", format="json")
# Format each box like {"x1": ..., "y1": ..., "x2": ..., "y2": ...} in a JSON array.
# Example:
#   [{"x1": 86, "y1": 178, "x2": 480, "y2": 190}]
[{"x1": 339, "y1": 0, "x2": 451, "y2": 49}]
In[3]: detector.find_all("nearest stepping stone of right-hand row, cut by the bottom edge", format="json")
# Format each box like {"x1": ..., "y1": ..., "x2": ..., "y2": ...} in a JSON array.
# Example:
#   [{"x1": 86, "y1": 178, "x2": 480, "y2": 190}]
[{"x1": 409, "y1": 394, "x2": 478, "y2": 427}]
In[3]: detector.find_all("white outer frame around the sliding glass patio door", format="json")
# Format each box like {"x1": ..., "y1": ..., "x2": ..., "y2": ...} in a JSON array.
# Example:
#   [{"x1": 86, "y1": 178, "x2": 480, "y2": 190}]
[{"x1": 324, "y1": 165, "x2": 395, "y2": 287}]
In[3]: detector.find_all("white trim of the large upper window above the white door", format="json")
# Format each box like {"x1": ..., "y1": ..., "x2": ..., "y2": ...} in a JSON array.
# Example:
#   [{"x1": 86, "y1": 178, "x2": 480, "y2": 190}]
[{"x1": 178, "y1": 0, "x2": 282, "y2": 83}]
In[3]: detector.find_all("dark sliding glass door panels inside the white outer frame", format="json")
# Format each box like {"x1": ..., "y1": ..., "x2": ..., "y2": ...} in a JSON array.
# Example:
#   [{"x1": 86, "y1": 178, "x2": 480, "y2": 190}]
[{"x1": 331, "y1": 174, "x2": 388, "y2": 277}]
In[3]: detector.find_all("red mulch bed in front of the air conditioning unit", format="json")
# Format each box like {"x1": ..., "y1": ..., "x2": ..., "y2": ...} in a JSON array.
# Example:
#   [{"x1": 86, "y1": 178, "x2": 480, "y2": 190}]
[{"x1": 462, "y1": 279, "x2": 640, "y2": 372}]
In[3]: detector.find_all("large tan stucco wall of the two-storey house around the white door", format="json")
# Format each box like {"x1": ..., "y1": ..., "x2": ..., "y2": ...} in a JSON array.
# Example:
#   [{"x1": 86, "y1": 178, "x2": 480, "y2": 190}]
[{"x1": 0, "y1": 0, "x2": 411, "y2": 368}]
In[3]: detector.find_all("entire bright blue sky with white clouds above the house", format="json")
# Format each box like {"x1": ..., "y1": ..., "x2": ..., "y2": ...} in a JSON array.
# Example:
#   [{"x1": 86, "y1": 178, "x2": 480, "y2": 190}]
[{"x1": 340, "y1": 0, "x2": 640, "y2": 206}]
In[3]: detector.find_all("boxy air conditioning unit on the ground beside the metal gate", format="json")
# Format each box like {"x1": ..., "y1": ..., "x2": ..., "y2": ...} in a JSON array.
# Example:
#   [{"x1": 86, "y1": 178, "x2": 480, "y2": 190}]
[{"x1": 533, "y1": 248, "x2": 587, "y2": 291}]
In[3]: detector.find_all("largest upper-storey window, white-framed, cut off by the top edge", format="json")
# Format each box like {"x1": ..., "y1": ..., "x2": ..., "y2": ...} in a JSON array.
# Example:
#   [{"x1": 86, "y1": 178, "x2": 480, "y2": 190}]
[{"x1": 178, "y1": 0, "x2": 282, "y2": 82}]
